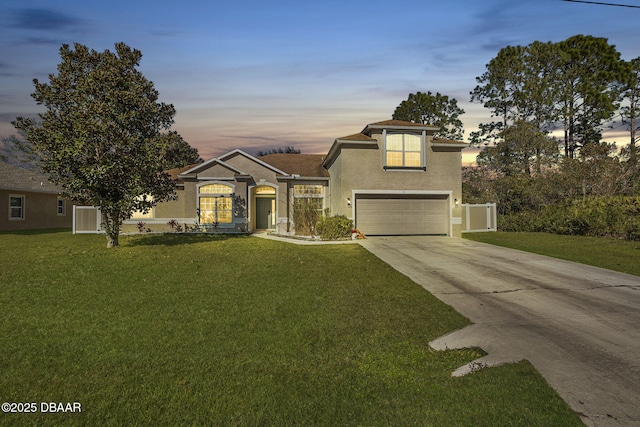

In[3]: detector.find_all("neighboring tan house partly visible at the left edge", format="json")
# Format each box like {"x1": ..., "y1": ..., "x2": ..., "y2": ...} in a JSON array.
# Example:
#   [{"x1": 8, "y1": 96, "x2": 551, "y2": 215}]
[{"x1": 0, "y1": 162, "x2": 73, "y2": 231}]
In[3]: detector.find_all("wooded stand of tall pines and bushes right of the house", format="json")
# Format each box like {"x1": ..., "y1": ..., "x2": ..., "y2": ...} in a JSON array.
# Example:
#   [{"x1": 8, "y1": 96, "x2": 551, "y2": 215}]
[{"x1": 463, "y1": 35, "x2": 640, "y2": 239}]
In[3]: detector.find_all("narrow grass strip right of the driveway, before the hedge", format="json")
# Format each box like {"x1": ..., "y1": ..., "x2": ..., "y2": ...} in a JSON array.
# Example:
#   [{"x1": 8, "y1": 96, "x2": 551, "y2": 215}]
[{"x1": 463, "y1": 231, "x2": 640, "y2": 276}]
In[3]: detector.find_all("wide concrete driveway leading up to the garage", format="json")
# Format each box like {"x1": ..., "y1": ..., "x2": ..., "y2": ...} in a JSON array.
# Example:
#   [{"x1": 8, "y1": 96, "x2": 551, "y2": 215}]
[{"x1": 361, "y1": 236, "x2": 640, "y2": 426}]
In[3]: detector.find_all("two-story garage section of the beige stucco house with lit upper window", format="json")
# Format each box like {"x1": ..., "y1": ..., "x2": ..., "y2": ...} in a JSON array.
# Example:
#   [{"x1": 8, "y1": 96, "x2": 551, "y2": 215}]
[{"x1": 323, "y1": 120, "x2": 467, "y2": 236}]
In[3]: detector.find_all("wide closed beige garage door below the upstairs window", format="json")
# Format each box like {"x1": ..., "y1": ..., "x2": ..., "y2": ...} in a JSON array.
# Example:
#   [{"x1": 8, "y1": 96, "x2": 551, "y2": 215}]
[{"x1": 356, "y1": 196, "x2": 449, "y2": 236}]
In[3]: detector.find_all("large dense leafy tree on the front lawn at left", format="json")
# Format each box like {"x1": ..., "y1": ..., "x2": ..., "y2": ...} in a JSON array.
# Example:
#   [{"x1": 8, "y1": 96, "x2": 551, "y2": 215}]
[{"x1": 13, "y1": 43, "x2": 188, "y2": 247}]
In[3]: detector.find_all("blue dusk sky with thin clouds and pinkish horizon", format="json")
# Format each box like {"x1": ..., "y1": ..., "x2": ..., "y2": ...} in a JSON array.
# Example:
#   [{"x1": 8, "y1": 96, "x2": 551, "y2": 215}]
[{"x1": 0, "y1": 0, "x2": 640, "y2": 165}]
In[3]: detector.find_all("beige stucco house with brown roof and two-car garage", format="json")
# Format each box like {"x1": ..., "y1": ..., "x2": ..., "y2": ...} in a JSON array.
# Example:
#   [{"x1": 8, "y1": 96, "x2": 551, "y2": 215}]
[{"x1": 123, "y1": 120, "x2": 467, "y2": 236}]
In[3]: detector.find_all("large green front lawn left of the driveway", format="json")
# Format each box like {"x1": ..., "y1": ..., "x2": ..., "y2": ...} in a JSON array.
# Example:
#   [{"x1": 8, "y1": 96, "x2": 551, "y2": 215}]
[{"x1": 0, "y1": 232, "x2": 581, "y2": 426}]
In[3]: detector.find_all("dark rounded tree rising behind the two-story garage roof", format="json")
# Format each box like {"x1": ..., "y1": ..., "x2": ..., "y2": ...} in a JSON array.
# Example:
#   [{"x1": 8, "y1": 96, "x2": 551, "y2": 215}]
[{"x1": 393, "y1": 92, "x2": 464, "y2": 140}]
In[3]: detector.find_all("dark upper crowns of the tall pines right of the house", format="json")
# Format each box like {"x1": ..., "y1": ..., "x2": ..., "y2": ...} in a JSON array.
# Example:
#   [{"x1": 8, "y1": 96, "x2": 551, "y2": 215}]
[{"x1": 471, "y1": 35, "x2": 623, "y2": 157}]
